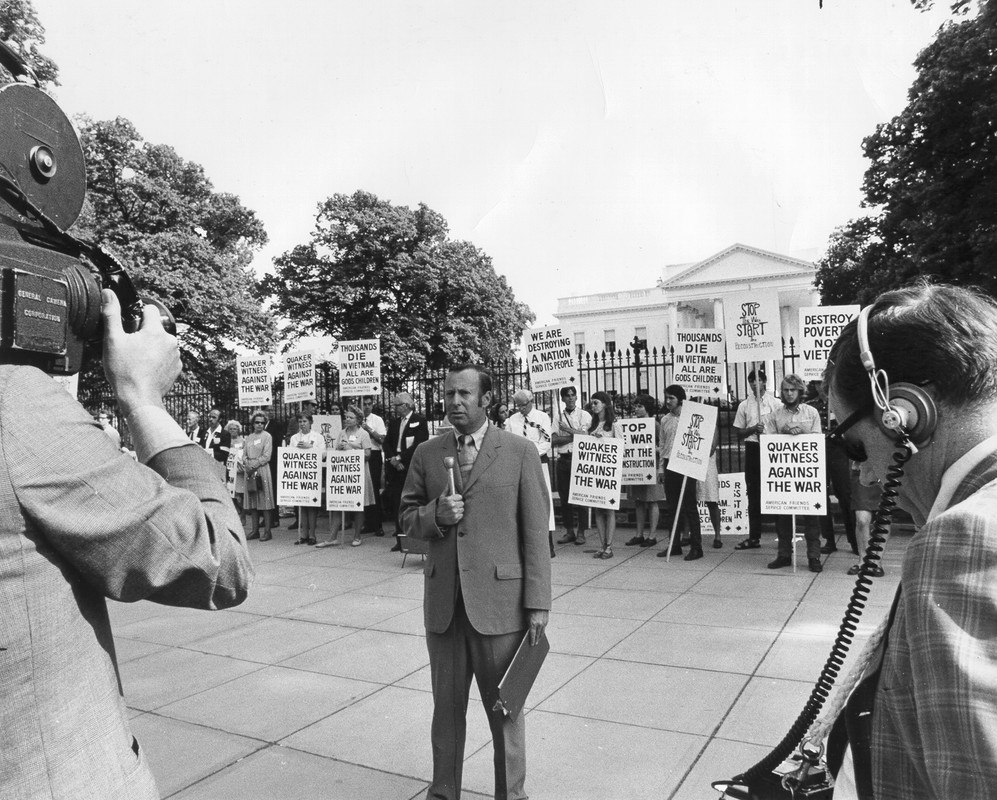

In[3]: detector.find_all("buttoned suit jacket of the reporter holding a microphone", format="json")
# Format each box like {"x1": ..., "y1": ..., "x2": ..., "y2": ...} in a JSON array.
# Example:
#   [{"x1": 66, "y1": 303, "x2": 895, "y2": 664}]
[{"x1": 400, "y1": 425, "x2": 551, "y2": 635}]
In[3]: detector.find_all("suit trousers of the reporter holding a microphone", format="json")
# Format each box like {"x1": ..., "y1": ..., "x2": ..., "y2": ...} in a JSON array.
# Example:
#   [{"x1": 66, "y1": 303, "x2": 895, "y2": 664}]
[{"x1": 426, "y1": 594, "x2": 526, "y2": 800}]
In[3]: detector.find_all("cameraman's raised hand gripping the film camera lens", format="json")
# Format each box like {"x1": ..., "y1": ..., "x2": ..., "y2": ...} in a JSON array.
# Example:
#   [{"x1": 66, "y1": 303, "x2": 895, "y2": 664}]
[{"x1": 100, "y1": 289, "x2": 181, "y2": 416}]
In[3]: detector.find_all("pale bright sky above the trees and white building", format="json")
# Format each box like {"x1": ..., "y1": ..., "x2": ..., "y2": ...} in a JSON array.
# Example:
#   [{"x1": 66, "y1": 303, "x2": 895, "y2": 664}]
[{"x1": 34, "y1": 0, "x2": 947, "y2": 325}]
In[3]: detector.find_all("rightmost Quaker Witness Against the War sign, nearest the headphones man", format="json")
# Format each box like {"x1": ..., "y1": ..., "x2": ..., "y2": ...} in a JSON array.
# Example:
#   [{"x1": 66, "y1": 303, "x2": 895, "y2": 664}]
[{"x1": 759, "y1": 433, "x2": 827, "y2": 516}]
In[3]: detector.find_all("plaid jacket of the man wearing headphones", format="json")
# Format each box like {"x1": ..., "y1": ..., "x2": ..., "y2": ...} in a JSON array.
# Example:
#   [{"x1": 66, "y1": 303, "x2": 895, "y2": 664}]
[{"x1": 872, "y1": 454, "x2": 997, "y2": 800}]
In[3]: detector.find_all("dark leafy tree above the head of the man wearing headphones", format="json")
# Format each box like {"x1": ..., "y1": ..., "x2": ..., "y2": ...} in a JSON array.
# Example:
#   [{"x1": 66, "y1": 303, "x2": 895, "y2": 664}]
[{"x1": 817, "y1": 3, "x2": 997, "y2": 303}]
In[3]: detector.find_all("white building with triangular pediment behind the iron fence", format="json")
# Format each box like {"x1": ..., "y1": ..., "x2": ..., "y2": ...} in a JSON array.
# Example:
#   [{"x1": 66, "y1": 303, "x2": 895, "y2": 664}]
[{"x1": 554, "y1": 244, "x2": 820, "y2": 353}]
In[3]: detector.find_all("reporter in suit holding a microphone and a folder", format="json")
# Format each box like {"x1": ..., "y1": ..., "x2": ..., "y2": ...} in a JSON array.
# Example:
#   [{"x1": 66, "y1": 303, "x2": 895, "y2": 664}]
[{"x1": 400, "y1": 366, "x2": 551, "y2": 800}]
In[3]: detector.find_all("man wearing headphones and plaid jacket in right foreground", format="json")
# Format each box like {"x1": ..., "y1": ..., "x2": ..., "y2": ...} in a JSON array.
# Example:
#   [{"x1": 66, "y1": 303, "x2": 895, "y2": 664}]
[{"x1": 825, "y1": 285, "x2": 997, "y2": 800}]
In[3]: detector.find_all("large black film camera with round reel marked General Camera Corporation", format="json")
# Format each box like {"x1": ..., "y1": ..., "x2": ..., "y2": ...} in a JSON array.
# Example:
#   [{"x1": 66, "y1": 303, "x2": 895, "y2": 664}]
[{"x1": 0, "y1": 42, "x2": 176, "y2": 375}]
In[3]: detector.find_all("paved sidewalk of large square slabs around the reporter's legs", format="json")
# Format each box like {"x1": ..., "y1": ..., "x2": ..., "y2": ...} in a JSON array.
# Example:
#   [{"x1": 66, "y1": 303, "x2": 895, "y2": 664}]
[{"x1": 110, "y1": 518, "x2": 910, "y2": 800}]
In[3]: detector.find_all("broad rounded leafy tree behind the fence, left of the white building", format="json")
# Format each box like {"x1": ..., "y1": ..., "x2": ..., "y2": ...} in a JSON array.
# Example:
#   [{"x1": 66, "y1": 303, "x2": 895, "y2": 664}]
[{"x1": 263, "y1": 191, "x2": 534, "y2": 378}]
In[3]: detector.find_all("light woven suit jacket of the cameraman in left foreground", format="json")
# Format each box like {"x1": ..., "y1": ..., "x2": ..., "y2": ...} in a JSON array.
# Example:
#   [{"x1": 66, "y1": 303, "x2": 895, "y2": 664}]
[{"x1": 0, "y1": 366, "x2": 252, "y2": 800}]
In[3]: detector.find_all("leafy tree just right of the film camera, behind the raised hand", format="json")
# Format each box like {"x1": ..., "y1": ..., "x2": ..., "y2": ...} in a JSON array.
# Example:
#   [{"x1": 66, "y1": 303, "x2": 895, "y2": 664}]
[{"x1": 74, "y1": 117, "x2": 275, "y2": 386}]
